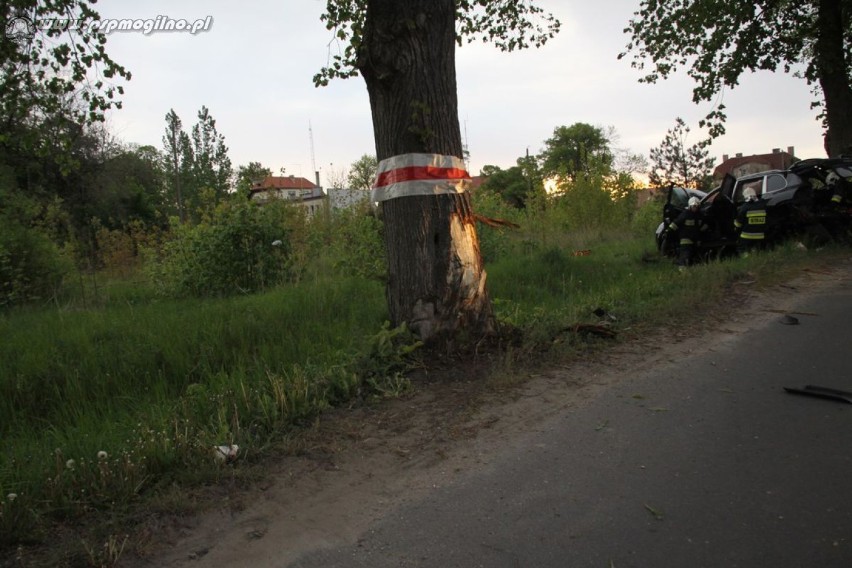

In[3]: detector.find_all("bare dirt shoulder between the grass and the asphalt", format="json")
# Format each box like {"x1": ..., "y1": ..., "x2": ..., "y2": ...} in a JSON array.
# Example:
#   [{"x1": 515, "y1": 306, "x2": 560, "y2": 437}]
[{"x1": 121, "y1": 260, "x2": 852, "y2": 568}]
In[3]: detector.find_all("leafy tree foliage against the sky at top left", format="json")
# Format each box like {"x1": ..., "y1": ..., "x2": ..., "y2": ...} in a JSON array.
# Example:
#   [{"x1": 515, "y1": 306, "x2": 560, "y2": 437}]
[{"x1": 0, "y1": 0, "x2": 130, "y2": 163}]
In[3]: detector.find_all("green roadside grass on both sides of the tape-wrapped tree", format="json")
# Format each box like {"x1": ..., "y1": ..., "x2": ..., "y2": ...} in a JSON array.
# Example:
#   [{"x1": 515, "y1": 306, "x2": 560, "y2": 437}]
[{"x1": 0, "y1": 215, "x2": 848, "y2": 565}]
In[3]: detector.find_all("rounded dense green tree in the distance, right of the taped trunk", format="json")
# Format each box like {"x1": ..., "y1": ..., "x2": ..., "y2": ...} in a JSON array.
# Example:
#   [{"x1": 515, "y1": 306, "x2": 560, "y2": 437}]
[{"x1": 539, "y1": 122, "x2": 613, "y2": 181}]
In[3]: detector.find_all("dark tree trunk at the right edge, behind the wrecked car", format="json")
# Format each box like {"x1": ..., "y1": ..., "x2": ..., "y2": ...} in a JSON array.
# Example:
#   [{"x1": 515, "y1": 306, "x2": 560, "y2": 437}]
[{"x1": 815, "y1": 0, "x2": 852, "y2": 157}]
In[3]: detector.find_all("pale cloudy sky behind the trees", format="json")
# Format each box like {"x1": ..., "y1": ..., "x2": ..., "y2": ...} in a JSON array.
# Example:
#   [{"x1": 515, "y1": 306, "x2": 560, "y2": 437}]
[{"x1": 95, "y1": 0, "x2": 825, "y2": 186}]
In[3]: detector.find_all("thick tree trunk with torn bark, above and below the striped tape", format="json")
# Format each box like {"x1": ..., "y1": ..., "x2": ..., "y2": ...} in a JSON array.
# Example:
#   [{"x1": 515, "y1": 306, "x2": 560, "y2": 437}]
[{"x1": 357, "y1": 0, "x2": 494, "y2": 340}]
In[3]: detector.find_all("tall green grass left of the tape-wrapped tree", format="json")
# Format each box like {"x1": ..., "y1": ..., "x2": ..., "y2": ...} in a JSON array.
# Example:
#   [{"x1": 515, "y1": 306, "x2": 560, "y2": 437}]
[{"x1": 0, "y1": 279, "x2": 386, "y2": 544}]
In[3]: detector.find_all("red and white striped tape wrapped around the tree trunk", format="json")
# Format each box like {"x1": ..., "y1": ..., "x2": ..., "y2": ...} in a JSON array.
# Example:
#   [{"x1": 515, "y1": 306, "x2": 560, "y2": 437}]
[{"x1": 372, "y1": 154, "x2": 470, "y2": 201}]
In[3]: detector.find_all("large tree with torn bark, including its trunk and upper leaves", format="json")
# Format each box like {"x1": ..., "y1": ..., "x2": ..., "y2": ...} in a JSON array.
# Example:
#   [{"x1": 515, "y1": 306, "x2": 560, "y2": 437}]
[{"x1": 315, "y1": 0, "x2": 559, "y2": 340}]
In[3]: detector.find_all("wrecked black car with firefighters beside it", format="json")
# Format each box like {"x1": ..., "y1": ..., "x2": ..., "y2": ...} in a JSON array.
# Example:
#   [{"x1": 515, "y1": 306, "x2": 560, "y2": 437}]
[{"x1": 656, "y1": 157, "x2": 852, "y2": 258}]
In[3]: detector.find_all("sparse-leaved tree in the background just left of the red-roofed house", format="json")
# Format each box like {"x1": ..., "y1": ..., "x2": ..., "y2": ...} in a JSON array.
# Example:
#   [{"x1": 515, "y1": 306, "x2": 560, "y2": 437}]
[{"x1": 648, "y1": 117, "x2": 715, "y2": 191}]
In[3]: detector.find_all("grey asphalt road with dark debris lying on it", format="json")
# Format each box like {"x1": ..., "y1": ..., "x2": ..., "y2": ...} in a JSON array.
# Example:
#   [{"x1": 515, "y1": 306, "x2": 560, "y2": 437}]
[{"x1": 289, "y1": 272, "x2": 852, "y2": 568}]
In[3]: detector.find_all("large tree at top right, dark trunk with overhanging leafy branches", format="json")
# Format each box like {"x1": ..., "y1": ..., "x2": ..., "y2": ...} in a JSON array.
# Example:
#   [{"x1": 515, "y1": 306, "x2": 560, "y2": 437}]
[{"x1": 619, "y1": 0, "x2": 852, "y2": 156}]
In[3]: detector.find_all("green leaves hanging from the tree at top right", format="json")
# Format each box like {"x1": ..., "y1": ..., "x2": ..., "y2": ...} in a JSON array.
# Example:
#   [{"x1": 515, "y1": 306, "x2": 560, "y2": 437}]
[{"x1": 618, "y1": 0, "x2": 852, "y2": 146}]
